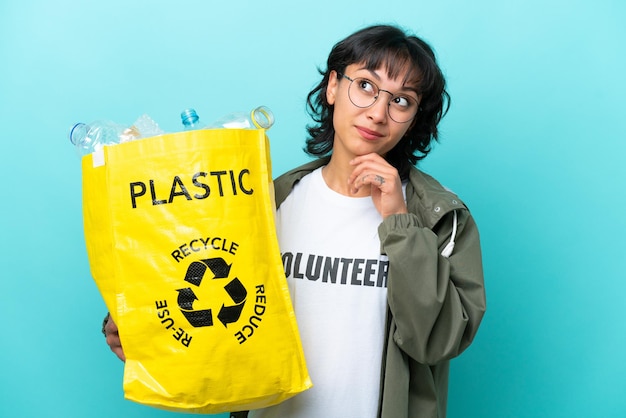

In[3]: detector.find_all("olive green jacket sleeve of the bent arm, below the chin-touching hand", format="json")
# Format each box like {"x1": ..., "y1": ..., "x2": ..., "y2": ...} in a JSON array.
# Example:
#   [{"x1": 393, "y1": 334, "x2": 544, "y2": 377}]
[{"x1": 379, "y1": 209, "x2": 486, "y2": 365}]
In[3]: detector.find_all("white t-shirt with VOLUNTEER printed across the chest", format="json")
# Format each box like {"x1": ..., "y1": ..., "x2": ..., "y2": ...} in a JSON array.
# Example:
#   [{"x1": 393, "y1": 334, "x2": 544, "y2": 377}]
[{"x1": 250, "y1": 169, "x2": 388, "y2": 418}]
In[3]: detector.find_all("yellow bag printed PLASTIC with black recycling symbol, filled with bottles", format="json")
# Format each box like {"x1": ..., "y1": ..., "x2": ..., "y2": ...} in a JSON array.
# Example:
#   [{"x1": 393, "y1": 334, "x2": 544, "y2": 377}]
[{"x1": 82, "y1": 129, "x2": 311, "y2": 413}]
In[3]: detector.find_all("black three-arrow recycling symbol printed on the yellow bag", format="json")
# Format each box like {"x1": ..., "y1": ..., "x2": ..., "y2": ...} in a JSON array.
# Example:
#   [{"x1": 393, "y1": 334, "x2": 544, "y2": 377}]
[{"x1": 176, "y1": 257, "x2": 248, "y2": 328}]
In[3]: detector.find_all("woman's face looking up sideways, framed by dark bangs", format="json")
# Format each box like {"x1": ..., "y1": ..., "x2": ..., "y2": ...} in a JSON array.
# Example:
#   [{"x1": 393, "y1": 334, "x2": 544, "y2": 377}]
[{"x1": 326, "y1": 64, "x2": 420, "y2": 159}]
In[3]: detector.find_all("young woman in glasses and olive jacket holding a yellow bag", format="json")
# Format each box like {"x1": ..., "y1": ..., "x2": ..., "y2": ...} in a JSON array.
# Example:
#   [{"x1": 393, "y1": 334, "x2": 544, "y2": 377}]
[{"x1": 105, "y1": 25, "x2": 486, "y2": 418}]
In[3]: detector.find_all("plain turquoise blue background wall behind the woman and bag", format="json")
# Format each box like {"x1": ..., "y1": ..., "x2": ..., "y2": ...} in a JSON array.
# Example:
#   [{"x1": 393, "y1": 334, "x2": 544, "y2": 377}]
[{"x1": 0, "y1": 0, "x2": 626, "y2": 418}]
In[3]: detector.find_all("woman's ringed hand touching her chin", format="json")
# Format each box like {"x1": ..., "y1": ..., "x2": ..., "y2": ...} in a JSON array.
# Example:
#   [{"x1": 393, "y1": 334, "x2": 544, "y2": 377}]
[{"x1": 348, "y1": 153, "x2": 408, "y2": 219}]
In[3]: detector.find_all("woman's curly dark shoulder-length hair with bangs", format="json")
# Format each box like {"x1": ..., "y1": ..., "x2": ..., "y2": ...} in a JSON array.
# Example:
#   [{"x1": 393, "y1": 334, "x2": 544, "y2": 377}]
[{"x1": 304, "y1": 25, "x2": 450, "y2": 179}]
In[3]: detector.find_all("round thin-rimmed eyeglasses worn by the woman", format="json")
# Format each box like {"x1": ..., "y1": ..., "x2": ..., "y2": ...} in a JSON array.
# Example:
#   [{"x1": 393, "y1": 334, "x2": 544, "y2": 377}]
[{"x1": 339, "y1": 74, "x2": 419, "y2": 123}]
